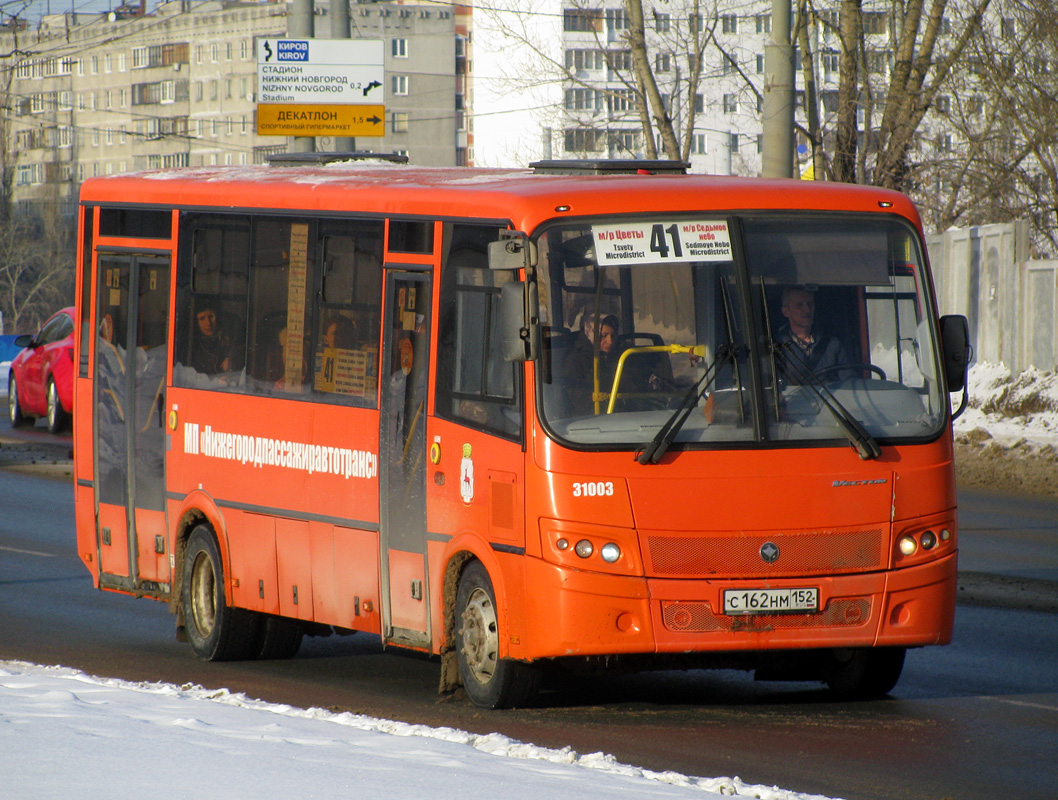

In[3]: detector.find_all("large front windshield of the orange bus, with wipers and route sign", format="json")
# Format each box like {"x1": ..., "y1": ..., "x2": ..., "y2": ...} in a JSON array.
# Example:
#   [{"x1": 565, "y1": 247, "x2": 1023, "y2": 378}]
[{"x1": 536, "y1": 214, "x2": 947, "y2": 450}]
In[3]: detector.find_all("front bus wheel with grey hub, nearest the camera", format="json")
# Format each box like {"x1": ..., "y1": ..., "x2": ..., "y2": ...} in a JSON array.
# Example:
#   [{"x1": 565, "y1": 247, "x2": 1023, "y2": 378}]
[{"x1": 456, "y1": 561, "x2": 540, "y2": 708}]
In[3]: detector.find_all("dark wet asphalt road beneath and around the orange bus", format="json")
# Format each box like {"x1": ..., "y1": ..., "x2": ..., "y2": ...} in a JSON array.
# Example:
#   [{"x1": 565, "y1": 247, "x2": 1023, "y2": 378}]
[{"x1": 0, "y1": 470, "x2": 1058, "y2": 800}]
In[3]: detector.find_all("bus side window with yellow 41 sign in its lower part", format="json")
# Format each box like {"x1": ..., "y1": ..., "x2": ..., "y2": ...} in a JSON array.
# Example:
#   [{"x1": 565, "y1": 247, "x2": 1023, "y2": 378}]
[{"x1": 313, "y1": 221, "x2": 383, "y2": 407}]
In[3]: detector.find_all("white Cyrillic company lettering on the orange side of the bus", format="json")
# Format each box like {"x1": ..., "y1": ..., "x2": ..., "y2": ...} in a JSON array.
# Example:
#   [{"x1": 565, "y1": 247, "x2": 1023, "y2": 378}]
[{"x1": 184, "y1": 422, "x2": 379, "y2": 478}]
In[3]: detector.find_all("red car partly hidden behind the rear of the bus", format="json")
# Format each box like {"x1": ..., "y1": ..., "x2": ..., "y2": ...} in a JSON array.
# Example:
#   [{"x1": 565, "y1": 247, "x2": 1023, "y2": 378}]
[{"x1": 7, "y1": 306, "x2": 75, "y2": 433}]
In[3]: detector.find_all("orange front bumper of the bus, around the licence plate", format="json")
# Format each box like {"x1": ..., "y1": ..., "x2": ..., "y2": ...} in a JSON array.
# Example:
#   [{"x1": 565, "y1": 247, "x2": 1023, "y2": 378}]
[{"x1": 520, "y1": 553, "x2": 956, "y2": 658}]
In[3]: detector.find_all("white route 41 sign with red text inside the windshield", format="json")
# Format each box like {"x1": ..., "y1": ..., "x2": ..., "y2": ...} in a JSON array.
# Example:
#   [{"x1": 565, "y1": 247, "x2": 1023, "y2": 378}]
[{"x1": 591, "y1": 219, "x2": 731, "y2": 267}]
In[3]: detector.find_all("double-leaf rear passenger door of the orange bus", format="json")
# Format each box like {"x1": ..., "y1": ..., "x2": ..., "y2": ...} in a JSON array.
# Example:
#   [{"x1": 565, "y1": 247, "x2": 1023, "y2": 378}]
[{"x1": 93, "y1": 252, "x2": 169, "y2": 594}]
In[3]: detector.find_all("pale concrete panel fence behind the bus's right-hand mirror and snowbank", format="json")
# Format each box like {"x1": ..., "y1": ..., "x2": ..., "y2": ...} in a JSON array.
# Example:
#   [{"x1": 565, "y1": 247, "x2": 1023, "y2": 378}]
[{"x1": 926, "y1": 222, "x2": 1058, "y2": 375}]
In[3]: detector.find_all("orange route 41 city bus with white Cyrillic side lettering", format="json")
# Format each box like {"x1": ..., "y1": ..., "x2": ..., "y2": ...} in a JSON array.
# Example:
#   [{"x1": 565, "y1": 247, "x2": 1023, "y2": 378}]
[{"x1": 73, "y1": 156, "x2": 967, "y2": 708}]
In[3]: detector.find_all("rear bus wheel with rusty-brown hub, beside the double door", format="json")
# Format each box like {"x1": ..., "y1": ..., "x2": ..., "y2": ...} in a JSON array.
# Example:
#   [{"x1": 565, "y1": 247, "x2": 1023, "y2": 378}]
[{"x1": 180, "y1": 525, "x2": 258, "y2": 661}]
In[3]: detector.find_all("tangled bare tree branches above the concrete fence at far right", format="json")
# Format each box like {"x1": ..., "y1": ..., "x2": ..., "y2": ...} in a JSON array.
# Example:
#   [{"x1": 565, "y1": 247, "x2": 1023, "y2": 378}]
[{"x1": 912, "y1": 0, "x2": 1058, "y2": 254}]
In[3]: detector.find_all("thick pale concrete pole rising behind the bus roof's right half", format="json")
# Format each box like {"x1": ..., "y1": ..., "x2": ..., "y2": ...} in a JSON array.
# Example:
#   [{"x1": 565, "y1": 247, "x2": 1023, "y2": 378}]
[{"x1": 761, "y1": 0, "x2": 794, "y2": 178}]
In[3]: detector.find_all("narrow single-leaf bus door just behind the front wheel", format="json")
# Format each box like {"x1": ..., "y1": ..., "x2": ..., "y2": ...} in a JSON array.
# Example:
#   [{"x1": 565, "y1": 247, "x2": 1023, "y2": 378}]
[{"x1": 379, "y1": 270, "x2": 431, "y2": 647}]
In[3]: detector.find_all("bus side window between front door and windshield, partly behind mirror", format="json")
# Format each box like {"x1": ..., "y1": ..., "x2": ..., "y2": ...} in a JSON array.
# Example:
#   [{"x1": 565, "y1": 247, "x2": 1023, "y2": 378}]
[{"x1": 436, "y1": 224, "x2": 522, "y2": 439}]
